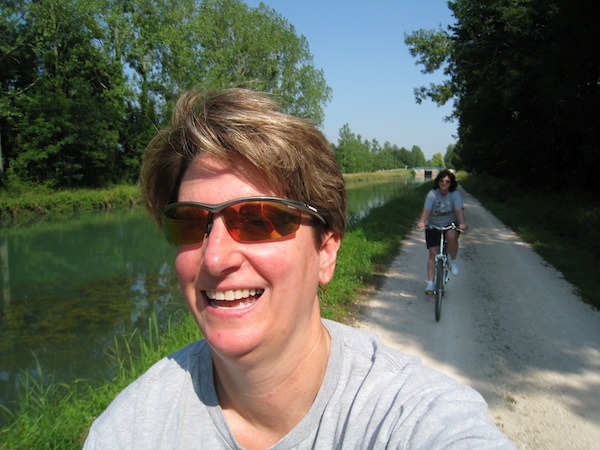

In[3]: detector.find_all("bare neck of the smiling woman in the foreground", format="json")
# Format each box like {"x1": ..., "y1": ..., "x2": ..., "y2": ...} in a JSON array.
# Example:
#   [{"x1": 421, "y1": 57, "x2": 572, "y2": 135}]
[{"x1": 213, "y1": 318, "x2": 330, "y2": 448}]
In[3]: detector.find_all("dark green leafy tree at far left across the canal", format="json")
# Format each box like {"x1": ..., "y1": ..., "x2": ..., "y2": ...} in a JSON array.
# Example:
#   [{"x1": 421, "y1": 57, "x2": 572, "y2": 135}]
[{"x1": 10, "y1": 0, "x2": 121, "y2": 187}]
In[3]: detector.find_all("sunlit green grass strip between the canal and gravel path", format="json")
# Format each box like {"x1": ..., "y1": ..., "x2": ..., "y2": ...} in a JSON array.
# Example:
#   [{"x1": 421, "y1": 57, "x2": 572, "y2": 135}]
[{"x1": 0, "y1": 180, "x2": 425, "y2": 449}]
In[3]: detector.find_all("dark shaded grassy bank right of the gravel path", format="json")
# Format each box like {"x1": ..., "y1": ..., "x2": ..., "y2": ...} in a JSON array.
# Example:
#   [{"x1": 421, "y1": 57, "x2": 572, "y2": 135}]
[{"x1": 460, "y1": 175, "x2": 600, "y2": 308}]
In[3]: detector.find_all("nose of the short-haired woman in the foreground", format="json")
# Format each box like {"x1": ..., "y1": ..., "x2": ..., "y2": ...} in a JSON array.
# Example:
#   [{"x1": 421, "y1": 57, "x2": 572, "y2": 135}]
[{"x1": 202, "y1": 215, "x2": 244, "y2": 276}]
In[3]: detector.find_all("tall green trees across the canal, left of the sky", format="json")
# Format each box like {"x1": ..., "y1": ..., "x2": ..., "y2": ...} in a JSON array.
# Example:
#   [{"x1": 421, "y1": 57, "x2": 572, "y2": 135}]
[{"x1": 0, "y1": 0, "x2": 331, "y2": 188}]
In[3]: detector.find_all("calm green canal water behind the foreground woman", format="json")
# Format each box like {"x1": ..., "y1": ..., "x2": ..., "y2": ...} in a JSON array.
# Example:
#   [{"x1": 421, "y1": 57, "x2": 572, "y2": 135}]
[{"x1": 0, "y1": 180, "x2": 418, "y2": 409}]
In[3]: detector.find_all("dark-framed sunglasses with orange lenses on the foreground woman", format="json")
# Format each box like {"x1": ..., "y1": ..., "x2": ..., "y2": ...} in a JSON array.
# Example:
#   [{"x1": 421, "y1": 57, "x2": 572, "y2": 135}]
[{"x1": 162, "y1": 197, "x2": 326, "y2": 245}]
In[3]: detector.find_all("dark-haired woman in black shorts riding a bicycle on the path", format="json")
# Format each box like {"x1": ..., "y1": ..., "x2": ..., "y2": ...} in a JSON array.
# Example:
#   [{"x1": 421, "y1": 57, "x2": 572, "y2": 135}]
[{"x1": 418, "y1": 170, "x2": 467, "y2": 295}]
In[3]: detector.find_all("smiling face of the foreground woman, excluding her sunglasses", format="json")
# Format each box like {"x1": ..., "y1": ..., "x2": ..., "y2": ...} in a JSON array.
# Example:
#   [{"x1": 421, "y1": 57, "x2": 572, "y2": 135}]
[{"x1": 175, "y1": 156, "x2": 340, "y2": 361}]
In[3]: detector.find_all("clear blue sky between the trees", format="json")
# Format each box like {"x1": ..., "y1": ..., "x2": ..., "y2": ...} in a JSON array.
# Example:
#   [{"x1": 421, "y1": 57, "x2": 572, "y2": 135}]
[{"x1": 245, "y1": 0, "x2": 456, "y2": 158}]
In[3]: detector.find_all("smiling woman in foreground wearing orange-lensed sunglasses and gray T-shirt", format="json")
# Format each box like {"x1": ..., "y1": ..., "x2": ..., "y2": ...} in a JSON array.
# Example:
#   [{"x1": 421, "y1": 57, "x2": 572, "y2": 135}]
[{"x1": 85, "y1": 89, "x2": 511, "y2": 449}]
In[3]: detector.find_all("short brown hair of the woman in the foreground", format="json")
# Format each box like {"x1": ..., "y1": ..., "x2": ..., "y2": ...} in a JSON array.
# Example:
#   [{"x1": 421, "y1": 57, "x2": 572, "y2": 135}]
[{"x1": 140, "y1": 89, "x2": 346, "y2": 241}]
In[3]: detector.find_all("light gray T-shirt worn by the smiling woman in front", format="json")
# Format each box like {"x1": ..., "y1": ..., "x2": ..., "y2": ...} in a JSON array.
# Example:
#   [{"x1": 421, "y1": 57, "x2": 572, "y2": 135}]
[{"x1": 84, "y1": 320, "x2": 514, "y2": 450}]
